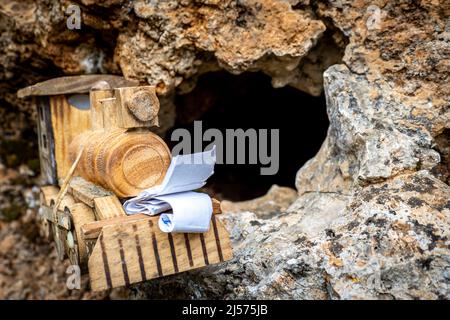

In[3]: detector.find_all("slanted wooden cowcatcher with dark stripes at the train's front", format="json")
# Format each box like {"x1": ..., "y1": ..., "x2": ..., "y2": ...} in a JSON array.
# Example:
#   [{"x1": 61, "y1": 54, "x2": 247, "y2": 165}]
[{"x1": 88, "y1": 216, "x2": 233, "y2": 291}]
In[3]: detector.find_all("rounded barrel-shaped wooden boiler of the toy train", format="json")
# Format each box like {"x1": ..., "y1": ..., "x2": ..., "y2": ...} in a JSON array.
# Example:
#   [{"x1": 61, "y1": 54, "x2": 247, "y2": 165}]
[{"x1": 69, "y1": 129, "x2": 171, "y2": 197}]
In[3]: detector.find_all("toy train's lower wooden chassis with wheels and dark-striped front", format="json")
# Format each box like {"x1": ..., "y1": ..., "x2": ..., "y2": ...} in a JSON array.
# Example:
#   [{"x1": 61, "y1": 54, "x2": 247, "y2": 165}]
[{"x1": 41, "y1": 185, "x2": 233, "y2": 291}]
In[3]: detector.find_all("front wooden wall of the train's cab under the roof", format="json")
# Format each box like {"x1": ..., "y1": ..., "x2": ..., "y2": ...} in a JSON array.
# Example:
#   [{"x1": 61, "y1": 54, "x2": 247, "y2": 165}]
[{"x1": 50, "y1": 96, "x2": 91, "y2": 179}]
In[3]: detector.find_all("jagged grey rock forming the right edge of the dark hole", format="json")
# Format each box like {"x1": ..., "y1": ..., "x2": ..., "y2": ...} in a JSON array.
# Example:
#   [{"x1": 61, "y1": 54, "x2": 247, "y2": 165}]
[{"x1": 297, "y1": 65, "x2": 449, "y2": 193}]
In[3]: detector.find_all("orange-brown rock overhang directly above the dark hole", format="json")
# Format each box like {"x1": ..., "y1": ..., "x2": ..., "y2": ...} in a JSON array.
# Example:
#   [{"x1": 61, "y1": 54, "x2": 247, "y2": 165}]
[{"x1": 116, "y1": 0, "x2": 325, "y2": 93}]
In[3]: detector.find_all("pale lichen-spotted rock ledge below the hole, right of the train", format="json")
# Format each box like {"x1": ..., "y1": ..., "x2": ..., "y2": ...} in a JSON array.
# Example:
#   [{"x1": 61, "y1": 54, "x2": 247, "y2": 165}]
[{"x1": 132, "y1": 171, "x2": 450, "y2": 299}]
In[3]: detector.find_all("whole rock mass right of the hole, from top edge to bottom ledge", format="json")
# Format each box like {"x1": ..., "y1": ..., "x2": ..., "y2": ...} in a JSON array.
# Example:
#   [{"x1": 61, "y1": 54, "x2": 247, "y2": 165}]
[{"x1": 131, "y1": 1, "x2": 450, "y2": 299}]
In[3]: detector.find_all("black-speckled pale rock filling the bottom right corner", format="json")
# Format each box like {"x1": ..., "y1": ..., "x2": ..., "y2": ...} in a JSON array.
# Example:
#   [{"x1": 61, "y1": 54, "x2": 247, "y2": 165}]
[{"x1": 325, "y1": 171, "x2": 450, "y2": 299}]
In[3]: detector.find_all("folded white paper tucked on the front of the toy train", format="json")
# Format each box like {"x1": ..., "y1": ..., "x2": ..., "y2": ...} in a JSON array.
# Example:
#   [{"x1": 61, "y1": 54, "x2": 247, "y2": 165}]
[{"x1": 123, "y1": 148, "x2": 216, "y2": 232}]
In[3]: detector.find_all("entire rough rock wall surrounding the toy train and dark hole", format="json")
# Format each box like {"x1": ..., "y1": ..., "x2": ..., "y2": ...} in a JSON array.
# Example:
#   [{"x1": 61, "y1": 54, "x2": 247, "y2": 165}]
[{"x1": 0, "y1": 0, "x2": 450, "y2": 299}]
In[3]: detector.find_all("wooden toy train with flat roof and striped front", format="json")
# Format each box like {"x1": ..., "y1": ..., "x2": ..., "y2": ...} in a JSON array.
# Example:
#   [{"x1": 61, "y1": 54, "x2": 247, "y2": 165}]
[{"x1": 18, "y1": 75, "x2": 232, "y2": 291}]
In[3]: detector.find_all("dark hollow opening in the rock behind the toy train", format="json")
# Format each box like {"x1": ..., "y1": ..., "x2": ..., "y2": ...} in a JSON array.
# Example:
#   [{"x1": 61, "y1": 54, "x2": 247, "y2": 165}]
[{"x1": 166, "y1": 71, "x2": 329, "y2": 201}]
